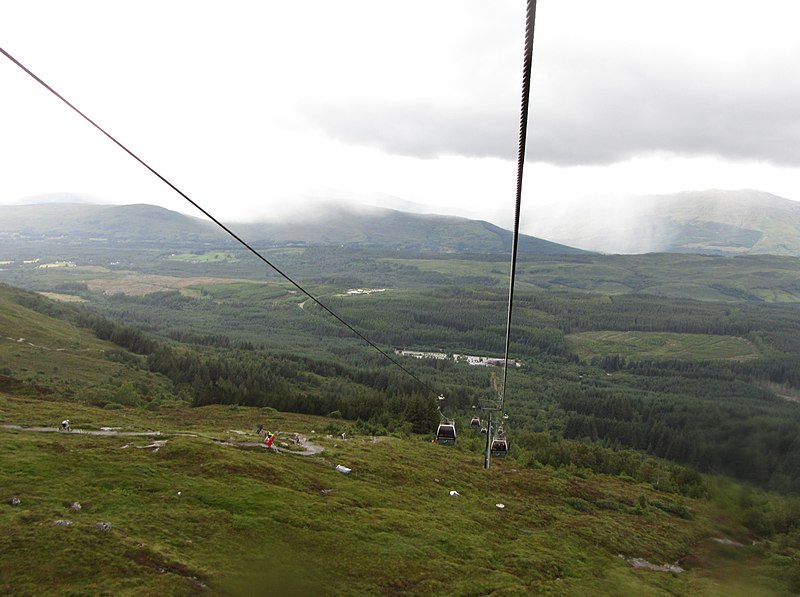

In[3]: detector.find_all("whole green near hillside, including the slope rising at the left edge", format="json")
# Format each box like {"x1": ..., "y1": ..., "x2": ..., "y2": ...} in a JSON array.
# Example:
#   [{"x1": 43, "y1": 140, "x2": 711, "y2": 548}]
[{"x1": 0, "y1": 286, "x2": 800, "y2": 595}]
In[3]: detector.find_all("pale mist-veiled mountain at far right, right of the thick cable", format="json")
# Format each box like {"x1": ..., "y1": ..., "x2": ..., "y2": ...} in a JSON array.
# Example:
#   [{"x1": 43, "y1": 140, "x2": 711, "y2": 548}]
[{"x1": 534, "y1": 189, "x2": 800, "y2": 256}]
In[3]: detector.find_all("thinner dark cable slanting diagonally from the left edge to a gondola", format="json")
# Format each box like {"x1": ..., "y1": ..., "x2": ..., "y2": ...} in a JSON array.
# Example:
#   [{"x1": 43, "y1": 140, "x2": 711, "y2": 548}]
[{"x1": 0, "y1": 47, "x2": 437, "y2": 395}]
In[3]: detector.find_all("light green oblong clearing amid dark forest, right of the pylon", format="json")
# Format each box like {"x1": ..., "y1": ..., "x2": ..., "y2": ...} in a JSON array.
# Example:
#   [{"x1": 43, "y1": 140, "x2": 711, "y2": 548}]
[{"x1": 566, "y1": 331, "x2": 760, "y2": 360}]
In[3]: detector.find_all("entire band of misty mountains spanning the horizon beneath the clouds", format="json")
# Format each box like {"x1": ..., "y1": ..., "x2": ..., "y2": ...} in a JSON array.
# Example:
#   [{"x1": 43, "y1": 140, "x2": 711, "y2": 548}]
[{"x1": 6, "y1": 190, "x2": 800, "y2": 257}]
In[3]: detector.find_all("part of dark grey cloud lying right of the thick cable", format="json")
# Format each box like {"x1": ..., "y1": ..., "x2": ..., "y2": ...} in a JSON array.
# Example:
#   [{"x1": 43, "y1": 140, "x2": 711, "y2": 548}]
[{"x1": 529, "y1": 54, "x2": 800, "y2": 165}]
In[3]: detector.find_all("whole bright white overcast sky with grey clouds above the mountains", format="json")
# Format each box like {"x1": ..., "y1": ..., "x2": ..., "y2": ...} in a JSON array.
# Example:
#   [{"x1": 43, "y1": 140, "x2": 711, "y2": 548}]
[{"x1": 0, "y1": 0, "x2": 800, "y2": 233}]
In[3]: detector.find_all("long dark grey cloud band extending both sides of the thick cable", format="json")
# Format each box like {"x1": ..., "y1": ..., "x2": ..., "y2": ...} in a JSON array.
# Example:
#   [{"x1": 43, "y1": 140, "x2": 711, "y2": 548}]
[{"x1": 306, "y1": 57, "x2": 800, "y2": 166}]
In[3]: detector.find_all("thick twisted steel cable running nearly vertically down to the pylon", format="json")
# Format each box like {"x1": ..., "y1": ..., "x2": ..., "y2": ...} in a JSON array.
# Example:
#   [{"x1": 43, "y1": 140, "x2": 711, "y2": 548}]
[{"x1": 498, "y1": 0, "x2": 536, "y2": 410}]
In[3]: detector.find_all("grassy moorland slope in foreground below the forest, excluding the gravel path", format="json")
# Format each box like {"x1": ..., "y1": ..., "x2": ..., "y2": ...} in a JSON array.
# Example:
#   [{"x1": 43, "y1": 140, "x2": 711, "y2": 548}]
[{"x1": 0, "y1": 395, "x2": 780, "y2": 595}]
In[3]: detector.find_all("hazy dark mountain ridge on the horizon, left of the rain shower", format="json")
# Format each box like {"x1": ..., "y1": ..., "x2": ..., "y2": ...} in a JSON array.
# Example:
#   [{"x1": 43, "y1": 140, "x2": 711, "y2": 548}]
[{"x1": 0, "y1": 203, "x2": 585, "y2": 255}]
